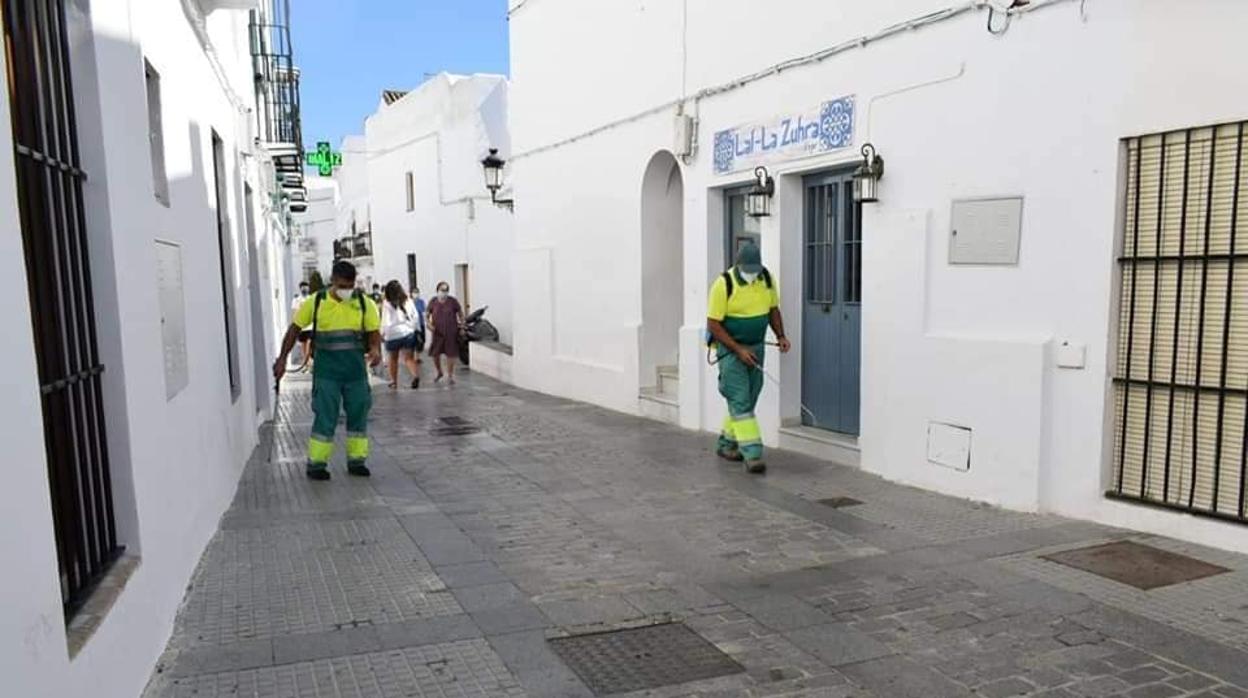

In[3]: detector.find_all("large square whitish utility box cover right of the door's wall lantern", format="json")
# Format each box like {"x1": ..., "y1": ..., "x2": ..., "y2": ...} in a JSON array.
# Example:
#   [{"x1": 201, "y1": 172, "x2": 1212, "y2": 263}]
[{"x1": 948, "y1": 196, "x2": 1022, "y2": 265}]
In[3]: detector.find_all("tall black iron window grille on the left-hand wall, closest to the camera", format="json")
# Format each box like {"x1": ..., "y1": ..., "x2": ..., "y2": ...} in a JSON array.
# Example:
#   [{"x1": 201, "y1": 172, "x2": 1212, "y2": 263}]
[{"x1": 0, "y1": 0, "x2": 122, "y2": 621}]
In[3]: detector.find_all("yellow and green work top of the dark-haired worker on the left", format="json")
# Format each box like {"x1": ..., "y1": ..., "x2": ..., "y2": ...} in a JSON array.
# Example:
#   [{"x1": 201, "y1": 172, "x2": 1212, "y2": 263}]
[{"x1": 295, "y1": 291, "x2": 382, "y2": 381}]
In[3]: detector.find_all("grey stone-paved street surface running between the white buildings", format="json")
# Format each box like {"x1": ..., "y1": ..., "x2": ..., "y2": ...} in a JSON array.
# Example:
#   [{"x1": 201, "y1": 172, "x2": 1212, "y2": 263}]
[{"x1": 146, "y1": 375, "x2": 1248, "y2": 698}]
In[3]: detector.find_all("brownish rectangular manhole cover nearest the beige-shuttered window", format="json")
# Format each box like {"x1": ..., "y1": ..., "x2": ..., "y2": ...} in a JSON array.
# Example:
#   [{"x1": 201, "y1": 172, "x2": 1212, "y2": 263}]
[{"x1": 1042, "y1": 541, "x2": 1231, "y2": 589}]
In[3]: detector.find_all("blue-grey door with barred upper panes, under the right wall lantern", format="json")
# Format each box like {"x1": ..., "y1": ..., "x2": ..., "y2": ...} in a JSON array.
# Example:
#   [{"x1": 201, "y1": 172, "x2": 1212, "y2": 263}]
[{"x1": 801, "y1": 171, "x2": 862, "y2": 435}]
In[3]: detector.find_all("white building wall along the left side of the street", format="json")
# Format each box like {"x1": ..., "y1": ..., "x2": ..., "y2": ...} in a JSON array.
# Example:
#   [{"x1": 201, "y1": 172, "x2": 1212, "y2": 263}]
[{"x1": 0, "y1": 0, "x2": 286, "y2": 698}]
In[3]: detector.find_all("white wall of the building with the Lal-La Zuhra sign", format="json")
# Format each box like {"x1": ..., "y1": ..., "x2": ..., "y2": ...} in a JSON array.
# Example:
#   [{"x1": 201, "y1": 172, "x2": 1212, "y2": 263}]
[{"x1": 508, "y1": 0, "x2": 1248, "y2": 549}]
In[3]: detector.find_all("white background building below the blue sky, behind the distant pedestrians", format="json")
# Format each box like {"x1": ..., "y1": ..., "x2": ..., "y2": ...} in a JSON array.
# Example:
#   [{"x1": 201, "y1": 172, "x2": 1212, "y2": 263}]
[{"x1": 364, "y1": 74, "x2": 514, "y2": 342}]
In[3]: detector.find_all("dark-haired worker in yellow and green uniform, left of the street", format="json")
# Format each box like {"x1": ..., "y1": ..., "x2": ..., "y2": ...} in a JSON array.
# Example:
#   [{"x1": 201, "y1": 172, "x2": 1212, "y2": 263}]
[{"x1": 273, "y1": 260, "x2": 382, "y2": 479}]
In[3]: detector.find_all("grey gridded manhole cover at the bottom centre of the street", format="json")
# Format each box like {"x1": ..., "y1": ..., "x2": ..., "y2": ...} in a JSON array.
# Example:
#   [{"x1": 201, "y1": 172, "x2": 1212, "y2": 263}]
[{"x1": 550, "y1": 623, "x2": 745, "y2": 696}]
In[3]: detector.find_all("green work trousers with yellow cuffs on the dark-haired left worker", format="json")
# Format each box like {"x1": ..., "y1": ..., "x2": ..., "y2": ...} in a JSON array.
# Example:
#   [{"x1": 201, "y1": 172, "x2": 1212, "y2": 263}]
[{"x1": 308, "y1": 374, "x2": 373, "y2": 469}]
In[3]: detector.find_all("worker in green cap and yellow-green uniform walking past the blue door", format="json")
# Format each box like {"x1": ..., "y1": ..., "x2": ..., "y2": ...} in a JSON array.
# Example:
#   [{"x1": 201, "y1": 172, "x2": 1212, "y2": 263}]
[{"x1": 706, "y1": 243, "x2": 790, "y2": 473}]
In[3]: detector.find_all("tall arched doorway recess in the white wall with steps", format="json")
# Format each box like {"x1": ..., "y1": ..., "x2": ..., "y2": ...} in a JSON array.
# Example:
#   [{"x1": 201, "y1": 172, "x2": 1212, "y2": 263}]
[{"x1": 640, "y1": 151, "x2": 685, "y2": 401}]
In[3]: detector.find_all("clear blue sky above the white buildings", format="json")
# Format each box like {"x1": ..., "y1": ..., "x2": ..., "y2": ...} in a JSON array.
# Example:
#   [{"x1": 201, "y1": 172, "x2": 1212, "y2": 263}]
[{"x1": 291, "y1": 0, "x2": 508, "y2": 147}]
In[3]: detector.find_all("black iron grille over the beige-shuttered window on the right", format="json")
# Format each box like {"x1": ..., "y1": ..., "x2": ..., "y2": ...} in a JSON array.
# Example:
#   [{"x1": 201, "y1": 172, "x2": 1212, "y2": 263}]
[{"x1": 1109, "y1": 122, "x2": 1248, "y2": 522}]
